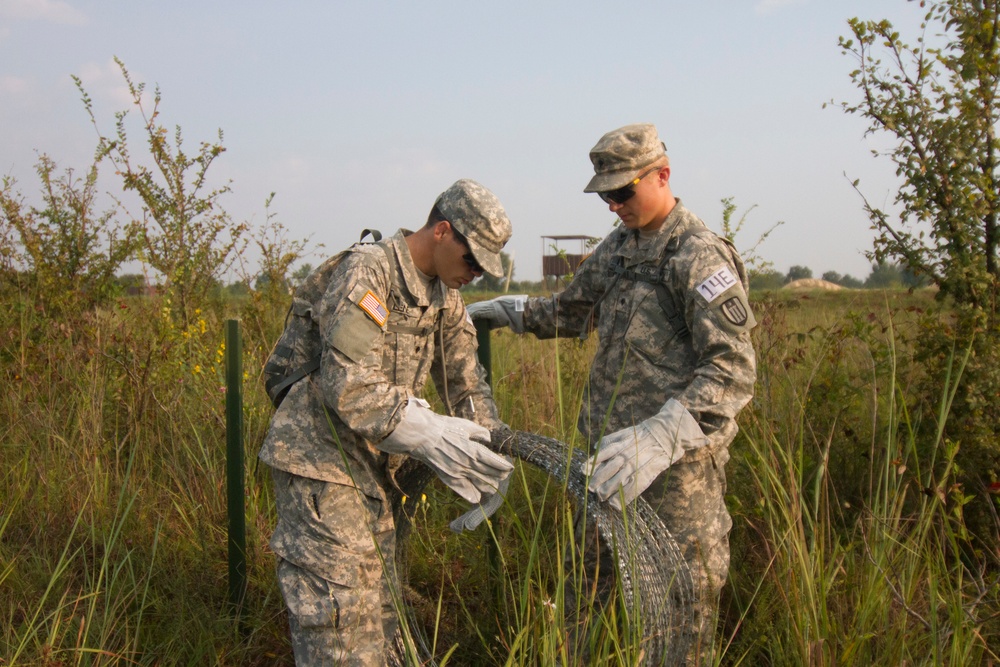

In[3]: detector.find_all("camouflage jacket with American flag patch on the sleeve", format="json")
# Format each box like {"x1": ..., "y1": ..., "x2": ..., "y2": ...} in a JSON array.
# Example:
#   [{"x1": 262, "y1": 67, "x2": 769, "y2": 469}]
[{"x1": 260, "y1": 230, "x2": 500, "y2": 497}]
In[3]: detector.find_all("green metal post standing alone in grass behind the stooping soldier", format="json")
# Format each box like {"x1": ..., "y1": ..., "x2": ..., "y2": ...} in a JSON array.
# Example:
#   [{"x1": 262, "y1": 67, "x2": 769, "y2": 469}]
[{"x1": 226, "y1": 320, "x2": 247, "y2": 609}]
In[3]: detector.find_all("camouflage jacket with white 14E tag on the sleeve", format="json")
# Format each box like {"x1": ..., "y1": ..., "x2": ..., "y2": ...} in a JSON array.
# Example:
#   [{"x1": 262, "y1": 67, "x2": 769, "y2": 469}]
[{"x1": 524, "y1": 200, "x2": 756, "y2": 459}]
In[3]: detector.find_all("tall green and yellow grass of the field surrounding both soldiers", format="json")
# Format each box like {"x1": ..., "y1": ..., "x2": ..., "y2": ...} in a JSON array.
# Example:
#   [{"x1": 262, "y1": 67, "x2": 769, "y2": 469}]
[{"x1": 0, "y1": 294, "x2": 1000, "y2": 667}]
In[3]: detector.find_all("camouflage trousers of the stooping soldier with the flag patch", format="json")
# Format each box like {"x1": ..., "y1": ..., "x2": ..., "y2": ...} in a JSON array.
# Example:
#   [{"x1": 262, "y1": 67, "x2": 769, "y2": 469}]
[{"x1": 271, "y1": 470, "x2": 398, "y2": 667}]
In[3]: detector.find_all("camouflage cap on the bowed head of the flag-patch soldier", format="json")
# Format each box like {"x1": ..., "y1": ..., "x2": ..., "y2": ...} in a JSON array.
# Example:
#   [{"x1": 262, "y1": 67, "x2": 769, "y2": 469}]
[{"x1": 434, "y1": 178, "x2": 511, "y2": 277}]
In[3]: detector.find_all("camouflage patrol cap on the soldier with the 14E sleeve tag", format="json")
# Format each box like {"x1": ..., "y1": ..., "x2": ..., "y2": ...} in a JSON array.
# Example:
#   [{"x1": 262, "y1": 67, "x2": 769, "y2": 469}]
[{"x1": 583, "y1": 123, "x2": 667, "y2": 192}]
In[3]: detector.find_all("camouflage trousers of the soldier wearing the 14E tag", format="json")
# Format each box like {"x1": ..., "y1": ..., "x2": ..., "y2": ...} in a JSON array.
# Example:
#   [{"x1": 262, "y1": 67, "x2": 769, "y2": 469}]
[{"x1": 565, "y1": 449, "x2": 733, "y2": 666}]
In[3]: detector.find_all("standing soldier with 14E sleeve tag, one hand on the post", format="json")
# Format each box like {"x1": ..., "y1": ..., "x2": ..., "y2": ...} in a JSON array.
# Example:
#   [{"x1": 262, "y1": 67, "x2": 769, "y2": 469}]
[{"x1": 469, "y1": 123, "x2": 756, "y2": 664}]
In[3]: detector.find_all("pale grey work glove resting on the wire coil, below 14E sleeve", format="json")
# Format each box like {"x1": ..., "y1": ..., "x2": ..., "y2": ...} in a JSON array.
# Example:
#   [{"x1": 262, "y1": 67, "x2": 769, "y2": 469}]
[{"x1": 585, "y1": 398, "x2": 708, "y2": 510}]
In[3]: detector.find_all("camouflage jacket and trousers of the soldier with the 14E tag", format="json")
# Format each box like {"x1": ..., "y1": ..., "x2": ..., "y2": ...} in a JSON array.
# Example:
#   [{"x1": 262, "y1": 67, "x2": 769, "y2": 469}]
[{"x1": 524, "y1": 200, "x2": 756, "y2": 658}]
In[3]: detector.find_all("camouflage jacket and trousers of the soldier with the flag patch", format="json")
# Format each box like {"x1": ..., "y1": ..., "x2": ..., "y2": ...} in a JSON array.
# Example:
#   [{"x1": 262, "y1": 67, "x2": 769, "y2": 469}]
[{"x1": 260, "y1": 230, "x2": 500, "y2": 667}]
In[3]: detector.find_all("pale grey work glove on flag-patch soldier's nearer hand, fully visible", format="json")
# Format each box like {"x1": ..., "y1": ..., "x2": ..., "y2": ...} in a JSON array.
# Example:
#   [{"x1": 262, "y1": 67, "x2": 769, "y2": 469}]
[{"x1": 378, "y1": 397, "x2": 514, "y2": 503}]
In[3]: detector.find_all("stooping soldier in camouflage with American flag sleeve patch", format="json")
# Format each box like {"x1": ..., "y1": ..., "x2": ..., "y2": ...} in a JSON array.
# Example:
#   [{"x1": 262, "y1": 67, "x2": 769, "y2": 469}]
[{"x1": 260, "y1": 179, "x2": 513, "y2": 667}]
